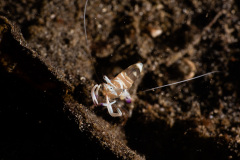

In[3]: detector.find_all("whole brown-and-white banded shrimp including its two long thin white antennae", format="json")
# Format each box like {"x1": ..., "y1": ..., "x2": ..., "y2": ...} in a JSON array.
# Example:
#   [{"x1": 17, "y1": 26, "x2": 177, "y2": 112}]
[{"x1": 84, "y1": 0, "x2": 219, "y2": 117}]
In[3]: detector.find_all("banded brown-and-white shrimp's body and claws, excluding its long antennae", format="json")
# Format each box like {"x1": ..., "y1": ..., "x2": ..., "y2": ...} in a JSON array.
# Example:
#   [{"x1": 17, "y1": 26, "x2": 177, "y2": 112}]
[{"x1": 91, "y1": 62, "x2": 143, "y2": 117}]
